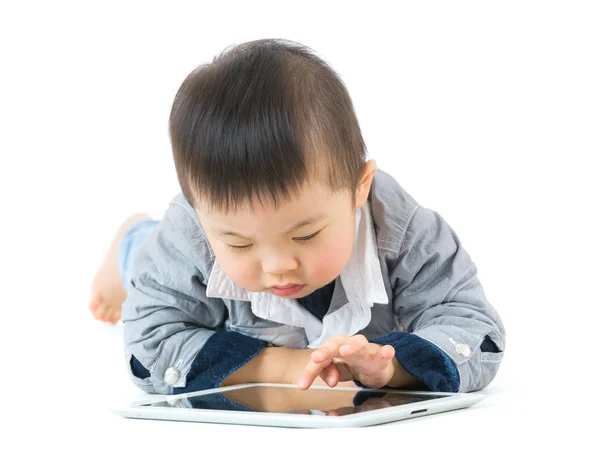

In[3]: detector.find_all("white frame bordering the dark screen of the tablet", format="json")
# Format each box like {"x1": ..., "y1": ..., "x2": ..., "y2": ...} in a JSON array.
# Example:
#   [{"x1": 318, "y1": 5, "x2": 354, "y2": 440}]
[{"x1": 110, "y1": 383, "x2": 485, "y2": 428}]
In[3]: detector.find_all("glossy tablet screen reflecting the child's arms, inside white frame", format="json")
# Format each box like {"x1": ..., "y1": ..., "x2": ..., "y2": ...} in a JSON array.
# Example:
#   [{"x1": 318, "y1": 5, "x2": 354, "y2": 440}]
[{"x1": 144, "y1": 386, "x2": 448, "y2": 416}]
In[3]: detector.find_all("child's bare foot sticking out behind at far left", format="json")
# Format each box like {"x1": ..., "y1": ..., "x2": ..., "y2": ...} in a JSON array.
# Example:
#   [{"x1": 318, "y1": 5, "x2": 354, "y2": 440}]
[{"x1": 89, "y1": 214, "x2": 150, "y2": 323}]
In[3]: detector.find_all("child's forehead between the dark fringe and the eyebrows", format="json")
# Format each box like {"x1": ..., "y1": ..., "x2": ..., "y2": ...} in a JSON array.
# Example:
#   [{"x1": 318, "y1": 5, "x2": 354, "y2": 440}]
[{"x1": 196, "y1": 183, "x2": 351, "y2": 232}]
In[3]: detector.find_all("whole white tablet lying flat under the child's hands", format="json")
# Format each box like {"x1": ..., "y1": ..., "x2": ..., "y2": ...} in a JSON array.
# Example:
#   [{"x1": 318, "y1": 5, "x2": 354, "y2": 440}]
[{"x1": 111, "y1": 384, "x2": 483, "y2": 428}]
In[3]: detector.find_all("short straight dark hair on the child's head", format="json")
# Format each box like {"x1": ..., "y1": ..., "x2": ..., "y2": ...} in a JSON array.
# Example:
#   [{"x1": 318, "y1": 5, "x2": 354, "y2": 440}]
[{"x1": 169, "y1": 39, "x2": 366, "y2": 211}]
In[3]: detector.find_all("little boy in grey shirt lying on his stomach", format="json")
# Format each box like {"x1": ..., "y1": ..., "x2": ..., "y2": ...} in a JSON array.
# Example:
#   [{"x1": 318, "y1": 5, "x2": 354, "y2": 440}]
[{"x1": 90, "y1": 40, "x2": 505, "y2": 394}]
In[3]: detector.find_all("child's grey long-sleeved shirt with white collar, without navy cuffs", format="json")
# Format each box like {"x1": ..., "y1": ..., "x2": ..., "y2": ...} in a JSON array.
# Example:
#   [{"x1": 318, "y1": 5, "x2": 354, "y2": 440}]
[{"x1": 122, "y1": 170, "x2": 505, "y2": 394}]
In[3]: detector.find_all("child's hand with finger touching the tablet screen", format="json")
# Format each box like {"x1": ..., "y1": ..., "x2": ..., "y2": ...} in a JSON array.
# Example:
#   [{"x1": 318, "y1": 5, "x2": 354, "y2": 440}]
[{"x1": 298, "y1": 335, "x2": 402, "y2": 389}]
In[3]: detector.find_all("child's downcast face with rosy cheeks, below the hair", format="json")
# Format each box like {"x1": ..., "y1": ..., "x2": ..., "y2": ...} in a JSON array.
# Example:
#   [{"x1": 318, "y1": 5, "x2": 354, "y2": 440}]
[{"x1": 196, "y1": 162, "x2": 374, "y2": 298}]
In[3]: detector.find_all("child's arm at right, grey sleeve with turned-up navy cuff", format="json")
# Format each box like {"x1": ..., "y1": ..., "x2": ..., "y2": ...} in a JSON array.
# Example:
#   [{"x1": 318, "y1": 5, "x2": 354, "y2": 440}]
[{"x1": 390, "y1": 207, "x2": 505, "y2": 392}]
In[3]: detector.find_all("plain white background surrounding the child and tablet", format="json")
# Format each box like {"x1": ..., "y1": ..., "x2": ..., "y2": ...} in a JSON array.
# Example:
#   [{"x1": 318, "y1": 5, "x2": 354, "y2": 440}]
[{"x1": 0, "y1": 1, "x2": 600, "y2": 450}]
